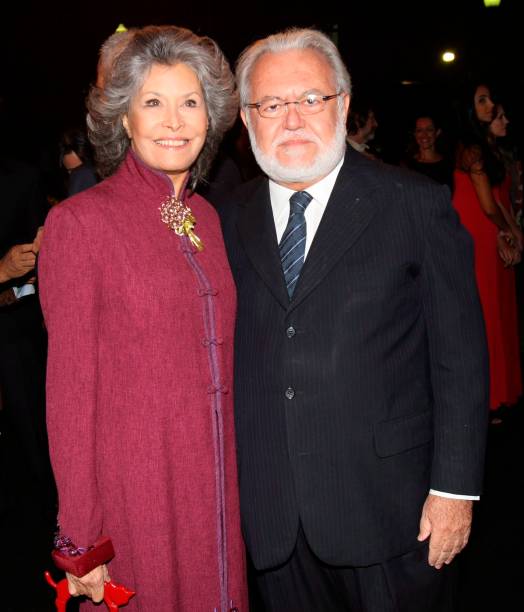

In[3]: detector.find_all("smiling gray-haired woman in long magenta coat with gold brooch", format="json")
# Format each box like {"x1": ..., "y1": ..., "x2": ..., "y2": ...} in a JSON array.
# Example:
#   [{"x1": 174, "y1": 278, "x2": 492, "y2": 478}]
[{"x1": 39, "y1": 26, "x2": 247, "y2": 612}]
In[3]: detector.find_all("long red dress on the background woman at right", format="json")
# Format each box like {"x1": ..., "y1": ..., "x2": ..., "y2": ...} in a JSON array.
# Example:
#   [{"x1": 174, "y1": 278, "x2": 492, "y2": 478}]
[{"x1": 453, "y1": 170, "x2": 522, "y2": 410}]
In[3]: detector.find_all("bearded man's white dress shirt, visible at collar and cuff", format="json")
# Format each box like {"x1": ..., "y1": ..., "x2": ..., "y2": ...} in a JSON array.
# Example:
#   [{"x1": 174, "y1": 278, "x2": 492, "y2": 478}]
[{"x1": 269, "y1": 158, "x2": 479, "y2": 499}]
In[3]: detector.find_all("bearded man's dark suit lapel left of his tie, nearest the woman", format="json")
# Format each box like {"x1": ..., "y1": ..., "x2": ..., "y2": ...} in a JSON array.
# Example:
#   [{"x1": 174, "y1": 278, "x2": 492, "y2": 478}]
[{"x1": 237, "y1": 179, "x2": 289, "y2": 310}]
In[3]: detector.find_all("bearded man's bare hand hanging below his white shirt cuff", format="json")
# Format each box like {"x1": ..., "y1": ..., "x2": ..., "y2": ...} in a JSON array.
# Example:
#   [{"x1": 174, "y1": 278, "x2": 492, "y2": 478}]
[{"x1": 417, "y1": 494, "x2": 473, "y2": 569}]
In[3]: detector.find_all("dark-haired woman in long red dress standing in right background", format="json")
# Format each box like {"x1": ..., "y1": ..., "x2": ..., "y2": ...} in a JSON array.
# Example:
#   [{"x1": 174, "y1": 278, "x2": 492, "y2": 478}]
[{"x1": 453, "y1": 84, "x2": 522, "y2": 422}]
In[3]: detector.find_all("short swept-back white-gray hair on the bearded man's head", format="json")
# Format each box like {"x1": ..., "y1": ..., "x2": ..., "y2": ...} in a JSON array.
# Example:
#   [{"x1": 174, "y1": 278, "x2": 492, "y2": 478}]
[{"x1": 235, "y1": 28, "x2": 351, "y2": 106}]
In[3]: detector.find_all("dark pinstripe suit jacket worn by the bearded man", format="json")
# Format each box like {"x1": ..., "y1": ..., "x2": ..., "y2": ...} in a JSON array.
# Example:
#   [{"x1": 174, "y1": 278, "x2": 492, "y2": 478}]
[{"x1": 219, "y1": 149, "x2": 488, "y2": 569}]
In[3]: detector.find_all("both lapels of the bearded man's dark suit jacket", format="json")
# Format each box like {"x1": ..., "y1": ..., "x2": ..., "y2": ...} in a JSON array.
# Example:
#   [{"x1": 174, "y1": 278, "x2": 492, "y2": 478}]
[{"x1": 238, "y1": 147, "x2": 381, "y2": 310}]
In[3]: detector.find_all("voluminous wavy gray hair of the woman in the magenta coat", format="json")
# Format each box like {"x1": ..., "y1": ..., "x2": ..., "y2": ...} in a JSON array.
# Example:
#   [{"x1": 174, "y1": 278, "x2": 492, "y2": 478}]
[{"x1": 87, "y1": 26, "x2": 238, "y2": 188}]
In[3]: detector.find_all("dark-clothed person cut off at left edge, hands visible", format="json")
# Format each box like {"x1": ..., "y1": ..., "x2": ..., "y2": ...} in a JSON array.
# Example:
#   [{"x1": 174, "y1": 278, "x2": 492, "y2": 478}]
[{"x1": 0, "y1": 89, "x2": 56, "y2": 612}]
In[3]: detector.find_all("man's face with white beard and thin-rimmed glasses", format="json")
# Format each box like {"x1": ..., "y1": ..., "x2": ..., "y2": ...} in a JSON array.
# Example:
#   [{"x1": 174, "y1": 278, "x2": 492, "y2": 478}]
[{"x1": 241, "y1": 49, "x2": 349, "y2": 189}]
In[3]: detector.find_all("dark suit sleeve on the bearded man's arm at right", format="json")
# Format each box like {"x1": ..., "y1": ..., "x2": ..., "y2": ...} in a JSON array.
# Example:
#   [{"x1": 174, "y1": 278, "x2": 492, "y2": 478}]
[{"x1": 422, "y1": 188, "x2": 489, "y2": 495}]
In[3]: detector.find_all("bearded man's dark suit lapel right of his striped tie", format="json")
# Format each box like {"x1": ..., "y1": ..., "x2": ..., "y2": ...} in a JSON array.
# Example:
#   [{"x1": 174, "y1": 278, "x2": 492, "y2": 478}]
[{"x1": 289, "y1": 147, "x2": 380, "y2": 310}]
